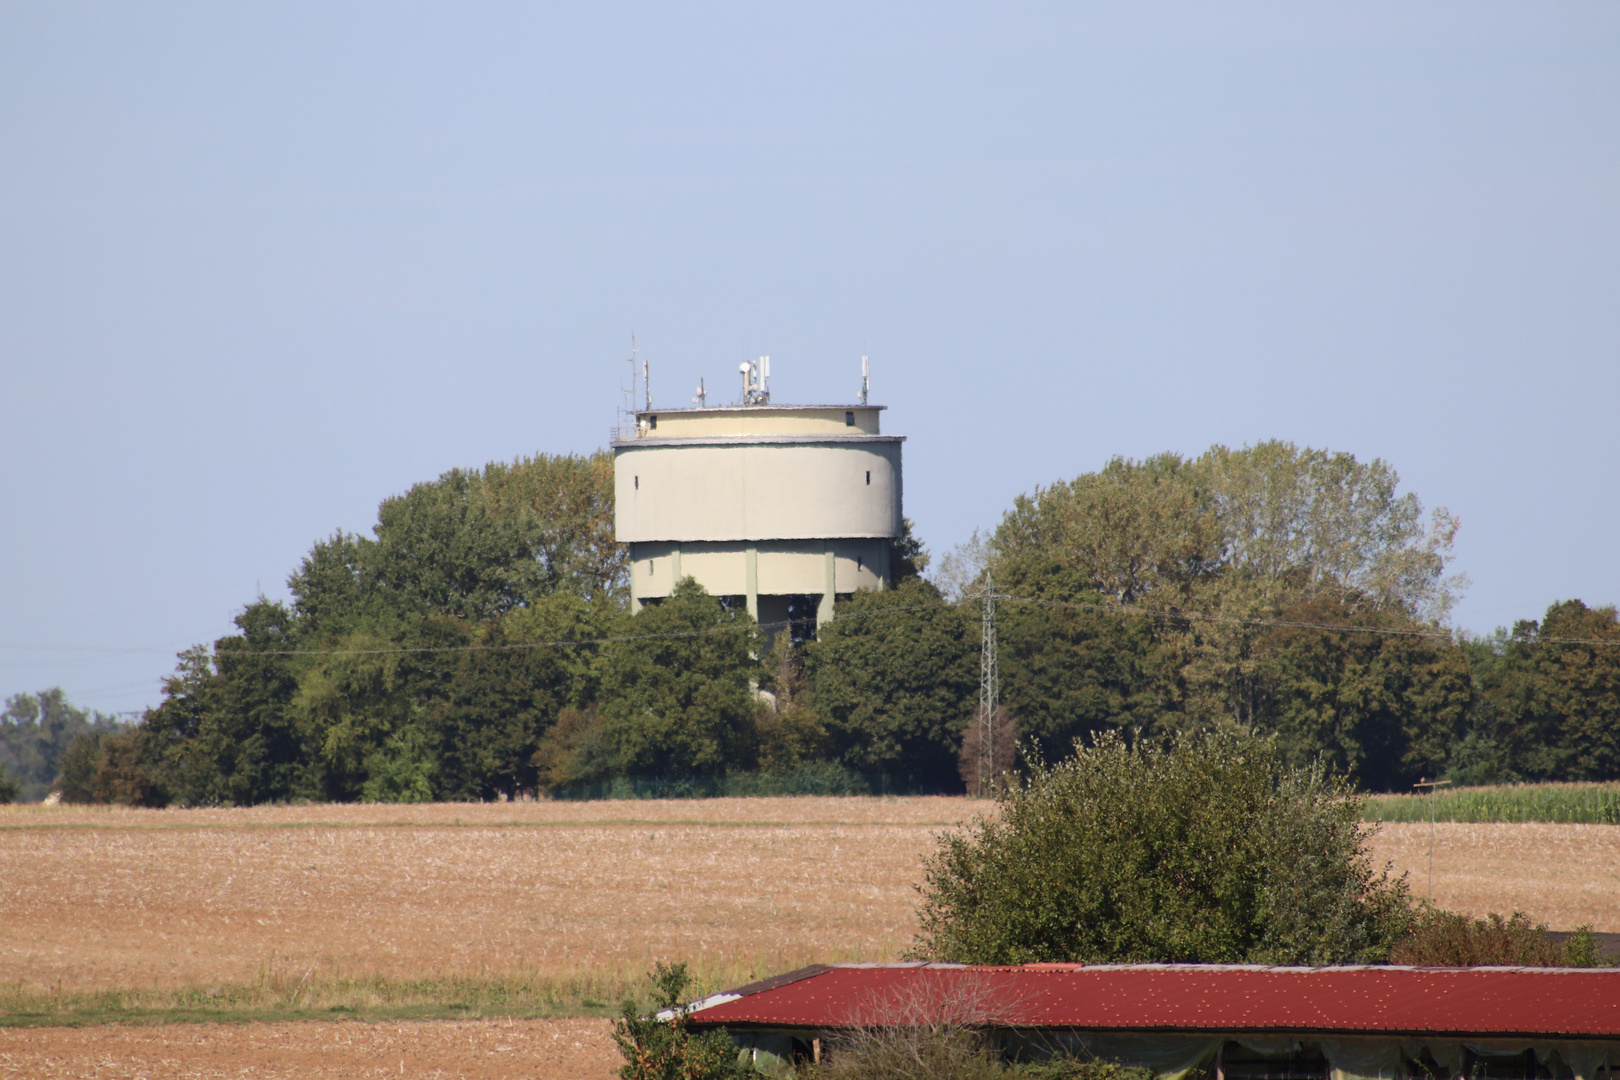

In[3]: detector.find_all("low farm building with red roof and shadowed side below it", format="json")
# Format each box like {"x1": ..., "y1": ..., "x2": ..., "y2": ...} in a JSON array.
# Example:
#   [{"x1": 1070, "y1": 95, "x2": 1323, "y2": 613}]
[{"x1": 690, "y1": 963, "x2": 1620, "y2": 1080}]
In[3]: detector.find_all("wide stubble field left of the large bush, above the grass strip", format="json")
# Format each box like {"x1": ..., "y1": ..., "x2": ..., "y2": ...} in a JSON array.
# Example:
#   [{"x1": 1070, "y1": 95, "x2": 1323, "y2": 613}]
[{"x1": 0, "y1": 798, "x2": 985, "y2": 993}]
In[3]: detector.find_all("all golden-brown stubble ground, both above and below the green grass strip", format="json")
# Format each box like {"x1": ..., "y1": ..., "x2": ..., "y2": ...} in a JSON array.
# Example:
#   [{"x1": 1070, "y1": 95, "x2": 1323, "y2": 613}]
[{"x1": 0, "y1": 798, "x2": 1620, "y2": 1078}]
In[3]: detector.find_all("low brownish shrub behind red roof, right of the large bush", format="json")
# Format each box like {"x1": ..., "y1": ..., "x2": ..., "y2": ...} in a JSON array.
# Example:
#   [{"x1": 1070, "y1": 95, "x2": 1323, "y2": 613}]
[{"x1": 1390, "y1": 908, "x2": 1599, "y2": 967}]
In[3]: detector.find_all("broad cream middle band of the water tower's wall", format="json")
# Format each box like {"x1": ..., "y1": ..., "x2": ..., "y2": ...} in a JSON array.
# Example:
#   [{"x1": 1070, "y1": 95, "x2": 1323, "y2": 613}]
[{"x1": 614, "y1": 439, "x2": 902, "y2": 544}]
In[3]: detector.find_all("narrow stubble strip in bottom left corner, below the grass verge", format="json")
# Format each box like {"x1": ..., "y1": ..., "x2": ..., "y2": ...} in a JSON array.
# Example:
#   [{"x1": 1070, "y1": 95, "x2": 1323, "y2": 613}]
[{"x1": 0, "y1": 1020, "x2": 622, "y2": 1080}]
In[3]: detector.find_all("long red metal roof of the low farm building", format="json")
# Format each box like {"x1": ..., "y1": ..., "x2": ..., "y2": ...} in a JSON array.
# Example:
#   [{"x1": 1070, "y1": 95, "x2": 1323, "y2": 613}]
[{"x1": 692, "y1": 963, "x2": 1620, "y2": 1038}]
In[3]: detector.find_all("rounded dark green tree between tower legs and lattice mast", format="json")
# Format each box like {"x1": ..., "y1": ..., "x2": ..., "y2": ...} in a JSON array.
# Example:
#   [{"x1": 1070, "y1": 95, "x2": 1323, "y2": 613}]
[{"x1": 805, "y1": 580, "x2": 978, "y2": 790}]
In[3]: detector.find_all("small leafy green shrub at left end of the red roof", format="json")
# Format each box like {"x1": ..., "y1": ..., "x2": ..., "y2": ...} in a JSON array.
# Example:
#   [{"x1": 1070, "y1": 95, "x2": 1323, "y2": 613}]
[{"x1": 612, "y1": 963, "x2": 744, "y2": 1080}]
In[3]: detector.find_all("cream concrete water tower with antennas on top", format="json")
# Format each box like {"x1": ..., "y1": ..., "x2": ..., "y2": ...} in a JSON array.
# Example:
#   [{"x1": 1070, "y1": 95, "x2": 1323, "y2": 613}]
[{"x1": 612, "y1": 356, "x2": 904, "y2": 628}]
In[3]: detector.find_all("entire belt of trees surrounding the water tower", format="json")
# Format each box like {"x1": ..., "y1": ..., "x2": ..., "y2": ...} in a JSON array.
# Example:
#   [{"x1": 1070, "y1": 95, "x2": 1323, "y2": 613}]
[{"x1": 38, "y1": 442, "x2": 1620, "y2": 805}]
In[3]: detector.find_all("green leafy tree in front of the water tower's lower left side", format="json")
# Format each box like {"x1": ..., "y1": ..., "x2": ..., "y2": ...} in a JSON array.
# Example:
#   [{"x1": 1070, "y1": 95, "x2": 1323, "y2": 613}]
[{"x1": 595, "y1": 578, "x2": 761, "y2": 777}]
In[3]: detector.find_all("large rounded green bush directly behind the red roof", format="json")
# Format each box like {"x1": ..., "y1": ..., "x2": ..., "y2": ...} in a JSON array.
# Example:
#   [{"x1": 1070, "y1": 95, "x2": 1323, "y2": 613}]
[{"x1": 917, "y1": 732, "x2": 1411, "y2": 965}]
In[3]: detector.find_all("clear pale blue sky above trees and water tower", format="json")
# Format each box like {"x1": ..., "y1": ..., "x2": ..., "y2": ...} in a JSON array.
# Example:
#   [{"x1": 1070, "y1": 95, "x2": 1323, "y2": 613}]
[{"x1": 0, "y1": 0, "x2": 1620, "y2": 709}]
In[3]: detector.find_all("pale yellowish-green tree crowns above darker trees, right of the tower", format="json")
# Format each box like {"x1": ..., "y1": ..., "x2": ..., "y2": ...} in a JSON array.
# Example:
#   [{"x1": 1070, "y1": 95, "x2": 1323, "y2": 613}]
[{"x1": 993, "y1": 442, "x2": 1464, "y2": 620}]
